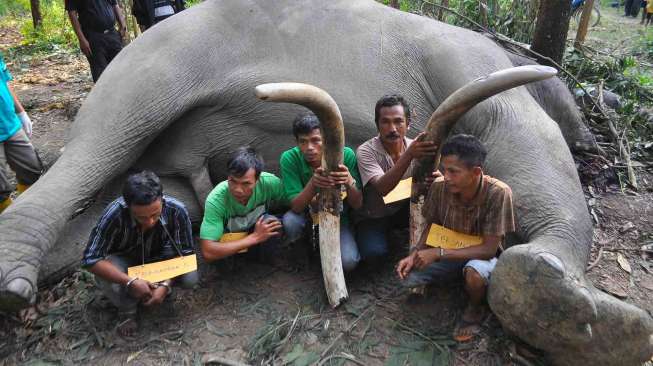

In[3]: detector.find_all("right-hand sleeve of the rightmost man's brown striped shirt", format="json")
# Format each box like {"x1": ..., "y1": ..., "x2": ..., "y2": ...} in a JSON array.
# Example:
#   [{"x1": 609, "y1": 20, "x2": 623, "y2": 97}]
[{"x1": 482, "y1": 185, "x2": 515, "y2": 236}]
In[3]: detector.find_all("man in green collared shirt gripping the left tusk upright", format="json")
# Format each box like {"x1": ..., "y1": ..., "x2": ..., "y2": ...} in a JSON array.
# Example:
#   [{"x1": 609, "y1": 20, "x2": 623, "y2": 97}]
[{"x1": 279, "y1": 114, "x2": 363, "y2": 271}]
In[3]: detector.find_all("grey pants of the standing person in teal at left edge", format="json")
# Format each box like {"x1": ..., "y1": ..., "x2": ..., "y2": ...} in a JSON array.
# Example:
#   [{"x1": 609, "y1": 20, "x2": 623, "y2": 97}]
[{"x1": 4, "y1": 129, "x2": 43, "y2": 192}]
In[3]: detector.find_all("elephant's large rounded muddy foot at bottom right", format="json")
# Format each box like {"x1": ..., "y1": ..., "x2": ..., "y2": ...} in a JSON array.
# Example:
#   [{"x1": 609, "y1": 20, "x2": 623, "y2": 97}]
[{"x1": 488, "y1": 244, "x2": 653, "y2": 365}]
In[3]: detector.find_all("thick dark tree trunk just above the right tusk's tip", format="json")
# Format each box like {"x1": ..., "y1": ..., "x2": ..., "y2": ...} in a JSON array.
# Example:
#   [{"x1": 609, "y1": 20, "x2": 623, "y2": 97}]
[{"x1": 531, "y1": 0, "x2": 571, "y2": 65}]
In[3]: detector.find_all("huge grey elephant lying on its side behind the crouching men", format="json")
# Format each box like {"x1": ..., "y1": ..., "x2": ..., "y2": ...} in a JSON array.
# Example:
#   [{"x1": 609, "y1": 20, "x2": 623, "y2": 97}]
[{"x1": 0, "y1": 0, "x2": 653, "y2": 365}]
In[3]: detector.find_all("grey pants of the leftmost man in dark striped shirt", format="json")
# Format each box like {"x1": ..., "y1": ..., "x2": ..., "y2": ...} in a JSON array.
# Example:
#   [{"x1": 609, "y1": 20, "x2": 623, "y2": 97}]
[{"x1": 95, "y1": 255, "x2": 199, "y2": 313}]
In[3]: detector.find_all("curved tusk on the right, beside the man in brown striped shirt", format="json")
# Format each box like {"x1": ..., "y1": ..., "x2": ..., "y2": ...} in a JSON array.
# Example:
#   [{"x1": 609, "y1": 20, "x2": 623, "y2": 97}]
[{"x1": 410, "y1": 65, "x2": 558, "y2": 247}]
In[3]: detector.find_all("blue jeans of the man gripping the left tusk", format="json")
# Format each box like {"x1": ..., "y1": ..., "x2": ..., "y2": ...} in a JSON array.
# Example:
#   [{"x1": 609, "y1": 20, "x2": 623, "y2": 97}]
[{"x1": 283, "y1": 210, "x2": 361, "y2": 272}]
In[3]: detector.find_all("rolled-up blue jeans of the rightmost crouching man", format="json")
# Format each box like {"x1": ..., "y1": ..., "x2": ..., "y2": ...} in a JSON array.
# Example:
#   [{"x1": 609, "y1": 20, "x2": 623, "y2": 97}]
[{"x1": 402, "y1": 258, "x2": 497, "y2": 287}]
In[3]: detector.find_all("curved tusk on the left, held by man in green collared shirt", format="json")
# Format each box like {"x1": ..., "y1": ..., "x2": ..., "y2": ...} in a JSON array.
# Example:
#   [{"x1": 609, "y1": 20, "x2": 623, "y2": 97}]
[{"x1": 255, "y1": 83, "x2": 349, "y2": 307}]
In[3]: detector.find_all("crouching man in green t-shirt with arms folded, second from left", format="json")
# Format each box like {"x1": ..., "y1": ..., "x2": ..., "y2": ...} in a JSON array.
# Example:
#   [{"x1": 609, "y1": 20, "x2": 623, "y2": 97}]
[{"x1": 200, "y1": 147, "x2": 288, "y2": 262}]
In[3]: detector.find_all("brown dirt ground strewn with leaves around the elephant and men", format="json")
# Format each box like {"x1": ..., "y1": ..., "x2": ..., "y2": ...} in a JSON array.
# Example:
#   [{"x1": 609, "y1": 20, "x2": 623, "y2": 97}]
[{"x1": 0, "y1": 5, "x2": 653, "y2": 365}]
